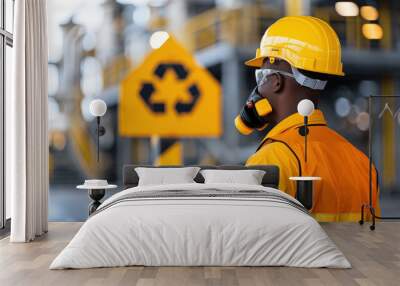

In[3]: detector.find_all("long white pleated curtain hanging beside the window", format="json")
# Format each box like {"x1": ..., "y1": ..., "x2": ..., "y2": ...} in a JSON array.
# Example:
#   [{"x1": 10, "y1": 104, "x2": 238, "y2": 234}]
[{"x1": 6, "y1": 0, "x2": 49, "y2": 242}]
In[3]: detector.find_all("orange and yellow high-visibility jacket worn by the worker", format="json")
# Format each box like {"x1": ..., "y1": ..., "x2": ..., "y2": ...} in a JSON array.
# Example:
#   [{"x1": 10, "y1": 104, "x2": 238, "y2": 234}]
[{"x1": 246, "y1": 110, "x2": 378, "y2": 221}]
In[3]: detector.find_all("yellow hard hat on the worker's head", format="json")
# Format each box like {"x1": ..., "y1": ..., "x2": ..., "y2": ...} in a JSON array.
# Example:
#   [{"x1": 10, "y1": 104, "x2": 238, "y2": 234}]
[{"x1": 246, "y1": 16, "x2": 344, "y2": 76}]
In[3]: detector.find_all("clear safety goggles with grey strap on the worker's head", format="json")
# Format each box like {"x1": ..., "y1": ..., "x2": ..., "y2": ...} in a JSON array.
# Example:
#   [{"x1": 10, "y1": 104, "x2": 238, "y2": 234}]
[{"x1": 255, "y1": 66, "x2": 327, "y2": 90}]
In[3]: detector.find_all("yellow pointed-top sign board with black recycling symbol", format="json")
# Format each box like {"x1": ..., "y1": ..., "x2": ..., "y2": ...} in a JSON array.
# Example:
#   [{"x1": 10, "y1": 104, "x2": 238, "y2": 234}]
[{"x1": 119, "y1": 37, "x2": 222, "y2": 137}]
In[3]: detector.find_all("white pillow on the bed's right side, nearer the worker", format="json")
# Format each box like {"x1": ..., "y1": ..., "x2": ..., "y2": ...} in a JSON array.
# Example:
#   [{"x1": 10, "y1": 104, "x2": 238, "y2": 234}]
[{"x1": 200, "y1": 170, "x2": 265, "y2": 185}]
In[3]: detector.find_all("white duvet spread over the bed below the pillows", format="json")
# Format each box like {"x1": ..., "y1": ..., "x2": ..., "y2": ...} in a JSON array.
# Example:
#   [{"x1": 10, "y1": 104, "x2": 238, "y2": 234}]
[{"x1": 50, "y1": 184, "x2": 351, "y2": 269}]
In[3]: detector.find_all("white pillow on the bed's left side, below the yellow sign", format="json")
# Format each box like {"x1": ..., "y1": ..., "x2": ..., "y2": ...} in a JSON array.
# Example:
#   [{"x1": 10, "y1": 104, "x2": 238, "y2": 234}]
[{"x1": 135, "y1": 167, "x2": 200, "y2": 186}]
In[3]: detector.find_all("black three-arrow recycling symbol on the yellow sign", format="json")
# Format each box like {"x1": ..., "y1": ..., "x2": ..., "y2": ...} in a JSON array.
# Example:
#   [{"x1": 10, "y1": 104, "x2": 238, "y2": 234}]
[{"x1": 139, "y1": 62, "x2": 200, "y2": 114}]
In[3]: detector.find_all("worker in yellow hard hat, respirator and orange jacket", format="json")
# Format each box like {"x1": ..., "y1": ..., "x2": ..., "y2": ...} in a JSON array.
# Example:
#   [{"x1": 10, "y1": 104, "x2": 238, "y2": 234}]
[{"x1": 235, "y1": 16, "x2": 377, "y2": 221}]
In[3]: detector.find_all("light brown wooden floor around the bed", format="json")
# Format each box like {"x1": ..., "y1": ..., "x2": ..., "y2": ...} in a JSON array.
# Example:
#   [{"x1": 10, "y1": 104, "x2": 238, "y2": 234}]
[{"x1": 0, "y1": 222, "x2": 400, "y2": 286}]
